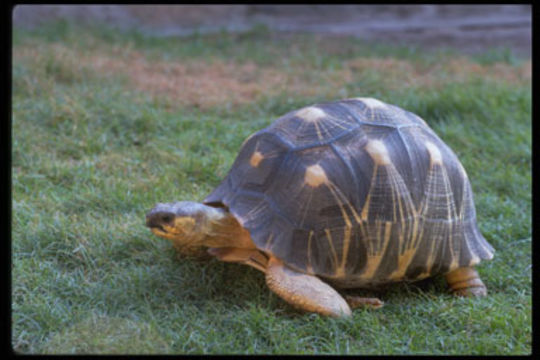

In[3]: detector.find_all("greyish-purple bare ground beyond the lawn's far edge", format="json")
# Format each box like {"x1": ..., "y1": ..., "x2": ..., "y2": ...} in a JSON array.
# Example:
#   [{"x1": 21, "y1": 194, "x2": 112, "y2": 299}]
[{"x1": 13, "y1": 5, "x2": 532, "y2": 57}]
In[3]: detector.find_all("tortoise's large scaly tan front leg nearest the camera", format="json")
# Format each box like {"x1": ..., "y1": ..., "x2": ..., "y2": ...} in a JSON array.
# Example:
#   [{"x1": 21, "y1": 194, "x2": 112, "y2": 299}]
[{"x1": 266, "y1": 257, "x2": 351, "y2": 317}]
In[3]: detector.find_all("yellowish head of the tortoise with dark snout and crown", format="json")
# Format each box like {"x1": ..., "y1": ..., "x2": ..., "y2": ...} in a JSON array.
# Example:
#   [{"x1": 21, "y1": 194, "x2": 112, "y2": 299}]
[{"x1": 146, "y1": 201, "x2": 213, "y2": 246}]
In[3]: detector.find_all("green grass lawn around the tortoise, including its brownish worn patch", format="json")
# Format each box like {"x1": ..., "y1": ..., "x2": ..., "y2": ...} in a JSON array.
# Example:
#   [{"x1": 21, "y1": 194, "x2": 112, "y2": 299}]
[{"x1": 12, "y1": 23, "x2": 532, "y2": 355}]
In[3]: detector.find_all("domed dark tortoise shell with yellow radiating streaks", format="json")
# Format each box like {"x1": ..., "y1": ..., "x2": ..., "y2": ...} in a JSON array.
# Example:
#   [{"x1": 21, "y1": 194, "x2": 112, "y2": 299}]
[{"x1": 204, "y1": 98, "x2": 493, "y2": 287}]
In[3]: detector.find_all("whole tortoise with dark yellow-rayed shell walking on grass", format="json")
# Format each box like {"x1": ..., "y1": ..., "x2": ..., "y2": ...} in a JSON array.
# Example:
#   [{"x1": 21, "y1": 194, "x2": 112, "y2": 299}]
[{"x1": 146, "y1": 98, "x2": 494, "y2": 317}]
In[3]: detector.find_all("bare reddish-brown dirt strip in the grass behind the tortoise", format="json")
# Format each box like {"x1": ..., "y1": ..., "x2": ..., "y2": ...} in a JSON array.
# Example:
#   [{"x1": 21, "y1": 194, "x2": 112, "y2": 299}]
[{"x1": 13, "y1": 38, "x2": 532, "y2": 108}]
